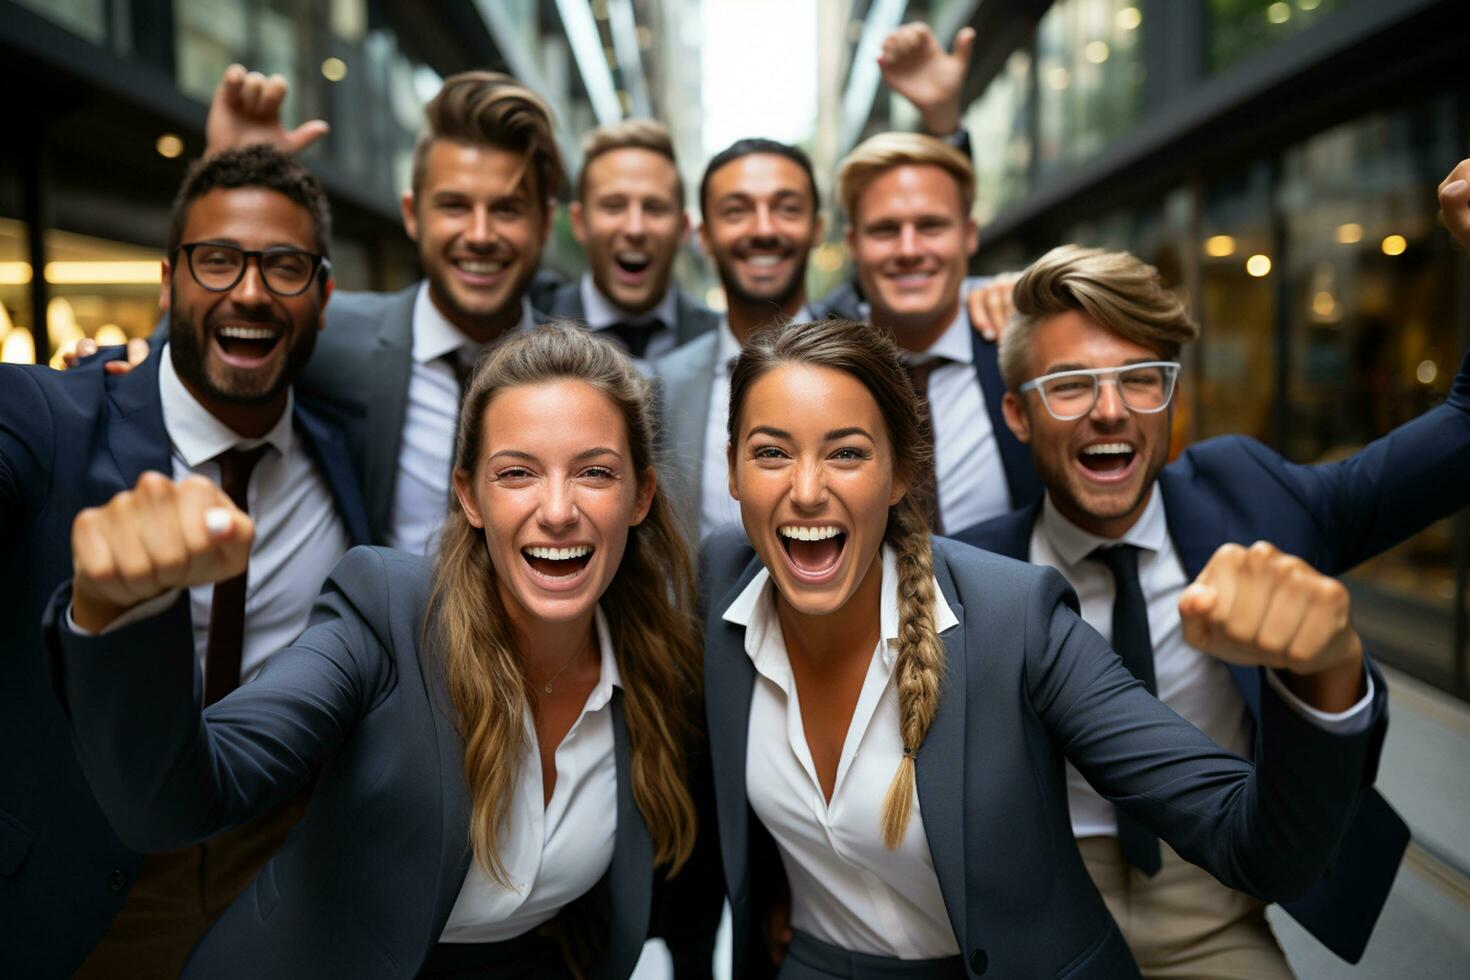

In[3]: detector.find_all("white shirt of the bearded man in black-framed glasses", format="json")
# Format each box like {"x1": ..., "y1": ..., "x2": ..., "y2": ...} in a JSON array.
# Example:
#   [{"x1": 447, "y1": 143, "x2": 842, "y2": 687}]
[{"x1": 158, "y1": 344, "x2": 351, "y2": 683}]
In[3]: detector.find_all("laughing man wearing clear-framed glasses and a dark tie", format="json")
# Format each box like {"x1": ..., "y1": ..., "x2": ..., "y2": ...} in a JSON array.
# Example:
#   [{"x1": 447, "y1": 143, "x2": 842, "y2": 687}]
[{"x1": 956, "y1": 207, "x2": 1470, "y2": 979}]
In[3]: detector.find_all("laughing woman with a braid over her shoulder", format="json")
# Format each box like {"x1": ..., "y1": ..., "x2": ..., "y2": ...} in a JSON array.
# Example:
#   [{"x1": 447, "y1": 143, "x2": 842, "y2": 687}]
[{"x1": 701, "y1": 320, "x2": 1382, "y2": 980}]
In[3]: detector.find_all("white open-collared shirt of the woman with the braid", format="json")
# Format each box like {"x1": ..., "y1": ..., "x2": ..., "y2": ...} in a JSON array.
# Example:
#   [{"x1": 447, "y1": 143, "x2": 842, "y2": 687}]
[{"x1": 723, "y1": 548, "x2": 960, "y2": 959}]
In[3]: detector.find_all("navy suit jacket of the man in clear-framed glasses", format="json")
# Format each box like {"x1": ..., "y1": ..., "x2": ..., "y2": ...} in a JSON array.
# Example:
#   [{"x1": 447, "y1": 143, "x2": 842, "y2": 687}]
[{"x1": 956, "y1": 348, "x2": 1470, "y2": 962}]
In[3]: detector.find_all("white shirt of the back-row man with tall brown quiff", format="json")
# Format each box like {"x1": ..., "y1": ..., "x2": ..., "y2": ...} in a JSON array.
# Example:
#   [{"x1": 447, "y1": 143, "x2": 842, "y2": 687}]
[{"x1": 388, "y1": 282, "x2": 535, "y2": 555}]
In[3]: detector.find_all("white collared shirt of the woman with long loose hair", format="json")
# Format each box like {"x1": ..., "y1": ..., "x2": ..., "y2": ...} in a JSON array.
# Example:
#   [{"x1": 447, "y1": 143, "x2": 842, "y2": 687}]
[{"x1": 440, "y1": 607, "x2": 622, "y2": 943}]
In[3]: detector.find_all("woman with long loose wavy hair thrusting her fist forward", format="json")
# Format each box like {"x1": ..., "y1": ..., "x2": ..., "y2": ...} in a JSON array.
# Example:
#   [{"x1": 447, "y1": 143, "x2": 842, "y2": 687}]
[{"x1": 56, "y1": 326, "x2": 698, "y2": 979}]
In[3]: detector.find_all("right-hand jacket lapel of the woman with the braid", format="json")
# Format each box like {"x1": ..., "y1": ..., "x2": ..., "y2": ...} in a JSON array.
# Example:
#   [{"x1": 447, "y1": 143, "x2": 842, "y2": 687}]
[{"x1": 911, "y1": 555, "x2": 969, "y2": 946}]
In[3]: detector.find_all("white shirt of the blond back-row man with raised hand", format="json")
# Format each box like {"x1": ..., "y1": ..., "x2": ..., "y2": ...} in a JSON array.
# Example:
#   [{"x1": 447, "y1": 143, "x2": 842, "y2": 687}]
[{"x1": 887, "y1": 303, "x2": 1011, "y2": 533}]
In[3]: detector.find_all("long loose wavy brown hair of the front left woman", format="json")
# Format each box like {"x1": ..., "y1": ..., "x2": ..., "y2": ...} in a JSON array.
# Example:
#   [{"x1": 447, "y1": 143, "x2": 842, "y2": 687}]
[{"x1": 423, "y1": 323, "x2": 700, "y2": 884}]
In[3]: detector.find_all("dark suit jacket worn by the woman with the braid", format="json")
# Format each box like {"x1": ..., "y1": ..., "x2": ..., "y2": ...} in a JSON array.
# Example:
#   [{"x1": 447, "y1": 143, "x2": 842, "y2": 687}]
[{"x1": 704, "y1": 529, "x2": 1386, "y2": 980}]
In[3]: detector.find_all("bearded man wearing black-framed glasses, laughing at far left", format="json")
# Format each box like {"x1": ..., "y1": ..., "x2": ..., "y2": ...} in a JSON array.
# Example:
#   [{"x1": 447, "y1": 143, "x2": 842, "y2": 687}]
[{"x1": 0, "y1": 147, "x2": 369, "y2": 979}]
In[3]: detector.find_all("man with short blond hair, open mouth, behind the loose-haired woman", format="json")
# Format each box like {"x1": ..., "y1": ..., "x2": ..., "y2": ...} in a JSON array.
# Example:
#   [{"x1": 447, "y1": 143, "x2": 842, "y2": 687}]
[{"x1": 544, "y1": 119, "x2": 719, "y2": 361}]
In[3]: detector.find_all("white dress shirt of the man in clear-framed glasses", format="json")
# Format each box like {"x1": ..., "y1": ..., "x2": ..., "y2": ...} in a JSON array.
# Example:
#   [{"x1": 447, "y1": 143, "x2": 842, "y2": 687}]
[{"x1": 1030, "y1": 489, "x2": 1373, "y2": 837}]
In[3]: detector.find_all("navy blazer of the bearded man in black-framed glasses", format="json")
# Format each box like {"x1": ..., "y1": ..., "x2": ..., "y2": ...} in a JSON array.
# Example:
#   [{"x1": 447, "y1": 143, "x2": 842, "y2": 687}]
[{"x1": 0, "y1": 348, "x2": 368, "y2": 977}]
